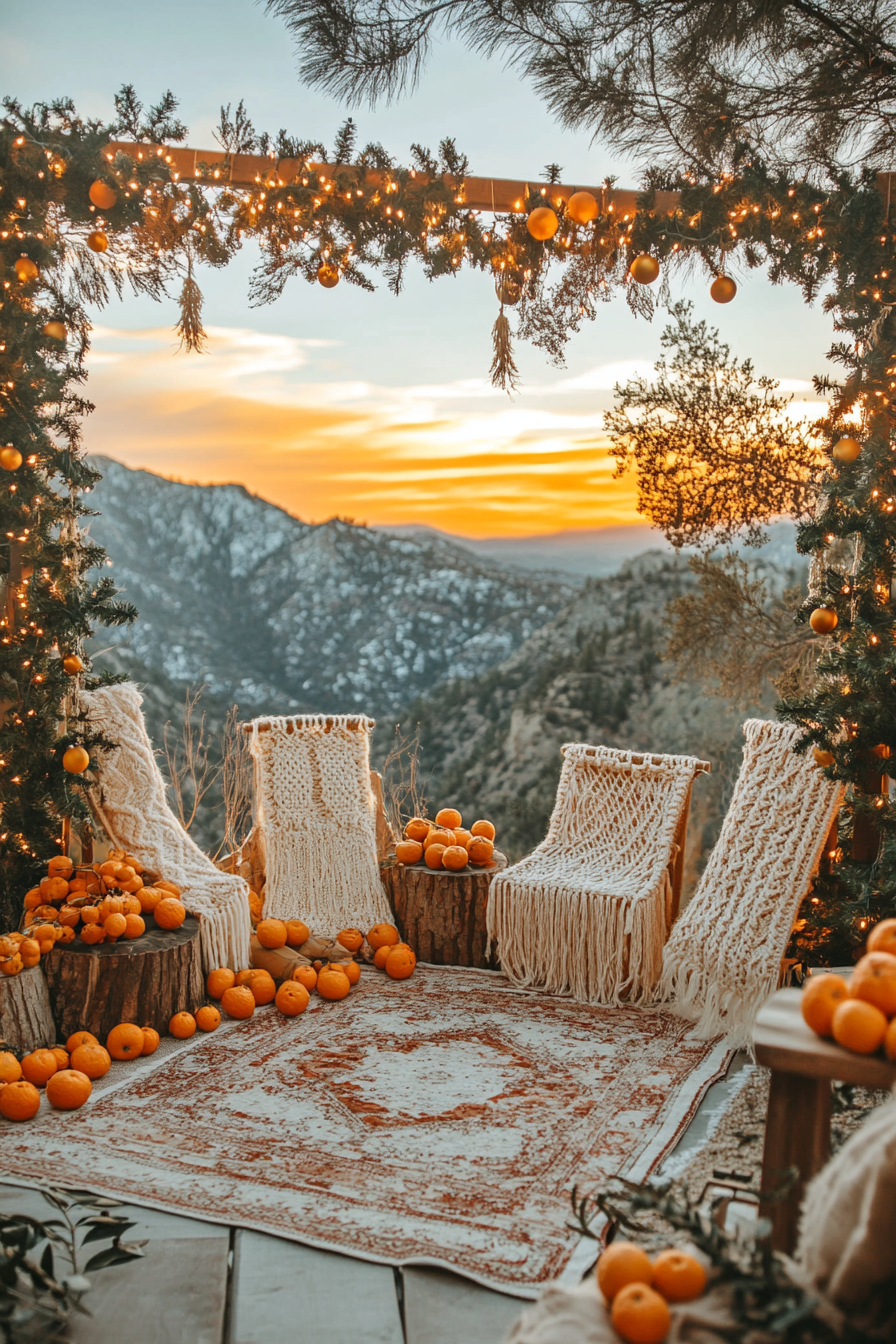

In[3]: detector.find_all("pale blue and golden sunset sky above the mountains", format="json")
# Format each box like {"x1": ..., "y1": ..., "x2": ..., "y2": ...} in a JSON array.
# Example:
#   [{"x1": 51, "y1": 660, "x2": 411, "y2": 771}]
[{"x1": 0, "y1": 0, "x2": 832, "y2": 536}]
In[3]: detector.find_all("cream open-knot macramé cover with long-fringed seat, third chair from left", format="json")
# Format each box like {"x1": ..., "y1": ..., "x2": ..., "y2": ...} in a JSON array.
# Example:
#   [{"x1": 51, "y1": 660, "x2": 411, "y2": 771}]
[{"x1": 488, "y1": 743, "x2": 700, "y2": 1004}]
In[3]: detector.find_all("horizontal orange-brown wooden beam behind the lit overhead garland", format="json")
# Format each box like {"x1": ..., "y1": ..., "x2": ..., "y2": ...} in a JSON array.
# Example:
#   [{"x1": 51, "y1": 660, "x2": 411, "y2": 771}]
[{"x1": 106, "y1": 141, "x2": 680, "y2": 219}]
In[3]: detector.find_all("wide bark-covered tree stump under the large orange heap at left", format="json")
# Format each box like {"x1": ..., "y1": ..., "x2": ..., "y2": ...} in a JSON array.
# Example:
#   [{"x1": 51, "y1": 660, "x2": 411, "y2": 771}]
[{"x1": 40, "y1": 915, "x2": 206, "y2": 1043}]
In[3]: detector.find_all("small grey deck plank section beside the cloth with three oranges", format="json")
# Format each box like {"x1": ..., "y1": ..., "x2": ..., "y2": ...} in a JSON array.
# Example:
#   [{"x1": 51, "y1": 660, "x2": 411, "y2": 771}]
[{"x1": 402, "y1": 1269, "x2": 527, "y2": 1344}]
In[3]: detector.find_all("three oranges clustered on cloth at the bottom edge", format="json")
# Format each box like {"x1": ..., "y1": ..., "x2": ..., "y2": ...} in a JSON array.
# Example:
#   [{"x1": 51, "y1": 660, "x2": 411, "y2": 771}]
[{"x1": 595, "y1": 1242, "x2": 707, "y2": 1344}]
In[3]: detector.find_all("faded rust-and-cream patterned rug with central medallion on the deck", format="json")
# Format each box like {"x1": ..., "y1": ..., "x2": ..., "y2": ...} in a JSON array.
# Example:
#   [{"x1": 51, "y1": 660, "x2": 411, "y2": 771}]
[{"x1": 0, "y1": 968, "x2": 729, "y2": 1297}]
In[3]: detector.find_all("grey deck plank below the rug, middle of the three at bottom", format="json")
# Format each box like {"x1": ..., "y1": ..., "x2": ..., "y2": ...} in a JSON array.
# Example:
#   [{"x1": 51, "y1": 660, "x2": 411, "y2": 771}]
[{"x1": 228, "y1": 1228, "x2": 403, "y2": 1344}]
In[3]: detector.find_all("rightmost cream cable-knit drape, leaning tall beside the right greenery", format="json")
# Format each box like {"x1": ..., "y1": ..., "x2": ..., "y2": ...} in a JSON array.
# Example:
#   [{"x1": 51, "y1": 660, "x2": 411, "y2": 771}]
[{"x1": 661, "y1": 719, "x2": 842, "y2": 1048}]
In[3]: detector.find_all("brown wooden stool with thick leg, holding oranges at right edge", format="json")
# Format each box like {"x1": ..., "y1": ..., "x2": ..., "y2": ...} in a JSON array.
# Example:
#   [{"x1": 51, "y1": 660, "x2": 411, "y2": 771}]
[{"x1": 754, "y1": 989, "x2": 896, "y2": 1255}]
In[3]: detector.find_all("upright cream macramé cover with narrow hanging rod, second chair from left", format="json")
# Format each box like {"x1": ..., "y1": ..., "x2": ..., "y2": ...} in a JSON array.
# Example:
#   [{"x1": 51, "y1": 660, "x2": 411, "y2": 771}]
[{"x1": 250, "y1": 715, "x2": 392, "y2": 935}]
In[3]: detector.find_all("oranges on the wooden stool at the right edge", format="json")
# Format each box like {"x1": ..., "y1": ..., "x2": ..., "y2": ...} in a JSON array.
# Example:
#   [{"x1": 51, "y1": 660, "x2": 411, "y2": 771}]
[{"x1": 801, "y1": 919, "x2": 896, "y2": 1060}]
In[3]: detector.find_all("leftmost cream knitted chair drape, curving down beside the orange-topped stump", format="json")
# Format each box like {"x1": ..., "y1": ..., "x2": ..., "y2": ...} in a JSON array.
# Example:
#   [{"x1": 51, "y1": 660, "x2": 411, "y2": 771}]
[{"x1": 82, "y1": 683, "x2": 253, "y2": 970}]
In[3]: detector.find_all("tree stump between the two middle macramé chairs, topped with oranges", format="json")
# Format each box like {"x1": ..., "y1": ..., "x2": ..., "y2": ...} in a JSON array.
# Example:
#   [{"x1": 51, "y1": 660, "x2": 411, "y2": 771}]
[{"x1": 380, "y1": 851, "x2": 506, "y2": 970}]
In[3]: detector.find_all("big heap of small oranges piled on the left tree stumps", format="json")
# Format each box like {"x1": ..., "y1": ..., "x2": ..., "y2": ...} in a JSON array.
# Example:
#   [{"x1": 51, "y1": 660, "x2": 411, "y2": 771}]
[{"x1": 10, "y1": 849, "x2": 187, "y2": 956}]
